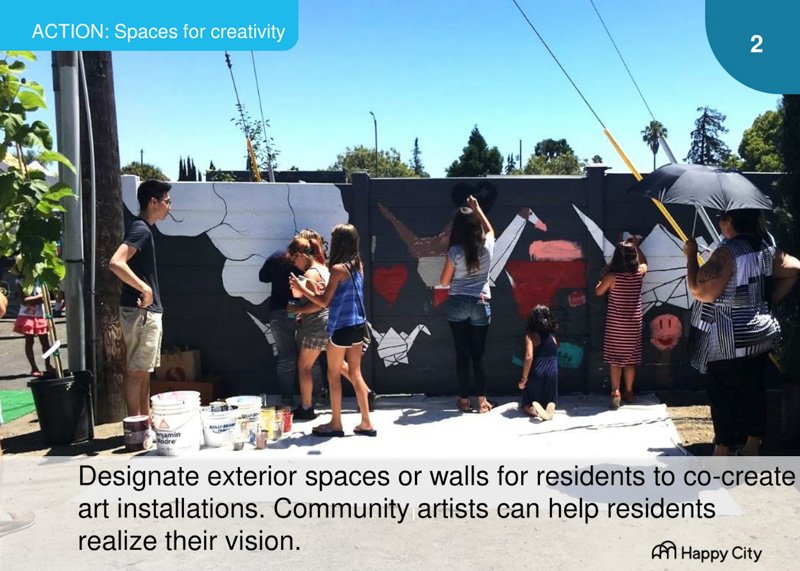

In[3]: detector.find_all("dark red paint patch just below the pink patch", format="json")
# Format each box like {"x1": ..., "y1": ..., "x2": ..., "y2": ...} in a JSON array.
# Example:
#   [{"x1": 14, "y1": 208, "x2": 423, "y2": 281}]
[{"x1": 506, "y1": 260, "x2": 586, "y2": 317}]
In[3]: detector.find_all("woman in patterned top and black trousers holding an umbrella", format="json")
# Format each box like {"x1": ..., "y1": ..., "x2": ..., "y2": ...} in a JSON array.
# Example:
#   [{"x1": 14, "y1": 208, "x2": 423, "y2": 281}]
[{"x1": 683, "y1": 208, "x2": 800, "y2": 456}]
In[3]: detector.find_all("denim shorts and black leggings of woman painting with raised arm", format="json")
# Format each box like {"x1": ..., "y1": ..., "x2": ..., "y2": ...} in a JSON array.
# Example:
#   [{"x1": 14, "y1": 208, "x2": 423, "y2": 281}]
[{"x1": 447, "y1": 295, "x2": 492, "y2": 398}]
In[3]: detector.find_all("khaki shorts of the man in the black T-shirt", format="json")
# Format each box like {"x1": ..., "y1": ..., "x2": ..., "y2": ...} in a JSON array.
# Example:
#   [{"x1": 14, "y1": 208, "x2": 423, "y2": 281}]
[{"x1": 119, "y1": 307, "x2": 163, "y2": 373}]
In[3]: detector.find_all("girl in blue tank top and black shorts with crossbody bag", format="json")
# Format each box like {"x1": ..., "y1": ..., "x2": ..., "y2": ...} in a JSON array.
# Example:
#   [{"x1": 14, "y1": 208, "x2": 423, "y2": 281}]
[{"x1": 289, "y1": 224, "x2": 377, "y2": 437}]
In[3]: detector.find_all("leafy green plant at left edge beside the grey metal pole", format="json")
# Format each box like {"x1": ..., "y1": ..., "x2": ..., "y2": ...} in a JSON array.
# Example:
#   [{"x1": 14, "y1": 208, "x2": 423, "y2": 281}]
[{"x1": 0, "y1": 51, "x2": 74, "y2": 288}]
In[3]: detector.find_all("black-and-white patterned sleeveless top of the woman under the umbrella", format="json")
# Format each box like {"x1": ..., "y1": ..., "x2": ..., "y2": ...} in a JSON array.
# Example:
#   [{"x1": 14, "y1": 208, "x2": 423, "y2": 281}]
[{"x1": 691, "y1": 237, "x2": 781, "y2": 373}]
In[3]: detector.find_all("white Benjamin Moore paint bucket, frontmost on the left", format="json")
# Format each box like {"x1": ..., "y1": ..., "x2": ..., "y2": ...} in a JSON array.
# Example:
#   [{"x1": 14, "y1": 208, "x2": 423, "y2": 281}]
[{"x1": 150, "y1": 391, "x2": 203, "y2": 456}]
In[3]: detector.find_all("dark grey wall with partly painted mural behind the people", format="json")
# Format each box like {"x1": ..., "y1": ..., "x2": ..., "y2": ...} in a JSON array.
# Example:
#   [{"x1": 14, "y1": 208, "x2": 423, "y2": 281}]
[{"x1": 123, "y1": 168, "x2": 775, "y2": 394}]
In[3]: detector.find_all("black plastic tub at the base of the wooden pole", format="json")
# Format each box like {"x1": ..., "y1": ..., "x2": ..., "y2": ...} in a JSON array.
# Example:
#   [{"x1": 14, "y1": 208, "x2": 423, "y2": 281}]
[{"x1": 28, "y1": 371, "x2": 94, "y2": 446}]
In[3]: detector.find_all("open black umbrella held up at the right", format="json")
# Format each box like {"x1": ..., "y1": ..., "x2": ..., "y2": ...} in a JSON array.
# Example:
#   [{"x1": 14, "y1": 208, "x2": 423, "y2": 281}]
[{"x1": 628, "y1": 164, "x2": 773, "y2": 212}]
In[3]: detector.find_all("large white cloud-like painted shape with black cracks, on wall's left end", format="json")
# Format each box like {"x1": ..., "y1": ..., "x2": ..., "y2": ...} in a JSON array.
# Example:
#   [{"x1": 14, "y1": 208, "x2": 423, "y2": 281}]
[{"x1": 122, "y1": 176, "x2": 348, "y2": 305}]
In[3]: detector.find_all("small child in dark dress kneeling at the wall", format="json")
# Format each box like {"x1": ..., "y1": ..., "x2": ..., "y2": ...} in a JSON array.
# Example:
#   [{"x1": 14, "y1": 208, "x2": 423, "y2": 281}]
[{"x1": 518, "y1": 305, "x2": 558, "y2": 421}]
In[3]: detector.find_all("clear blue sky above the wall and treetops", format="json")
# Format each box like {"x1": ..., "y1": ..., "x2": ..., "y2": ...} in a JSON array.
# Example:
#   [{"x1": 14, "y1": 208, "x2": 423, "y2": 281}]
[{"x1": 20, "y1": 0, "x2": 780, "y2": 178}]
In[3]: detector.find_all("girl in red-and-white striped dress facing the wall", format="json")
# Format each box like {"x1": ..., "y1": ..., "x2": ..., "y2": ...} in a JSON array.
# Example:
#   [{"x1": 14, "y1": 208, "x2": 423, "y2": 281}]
[{"x1": 594, "y1": 236, "x2": 647, "y2": 410}]
